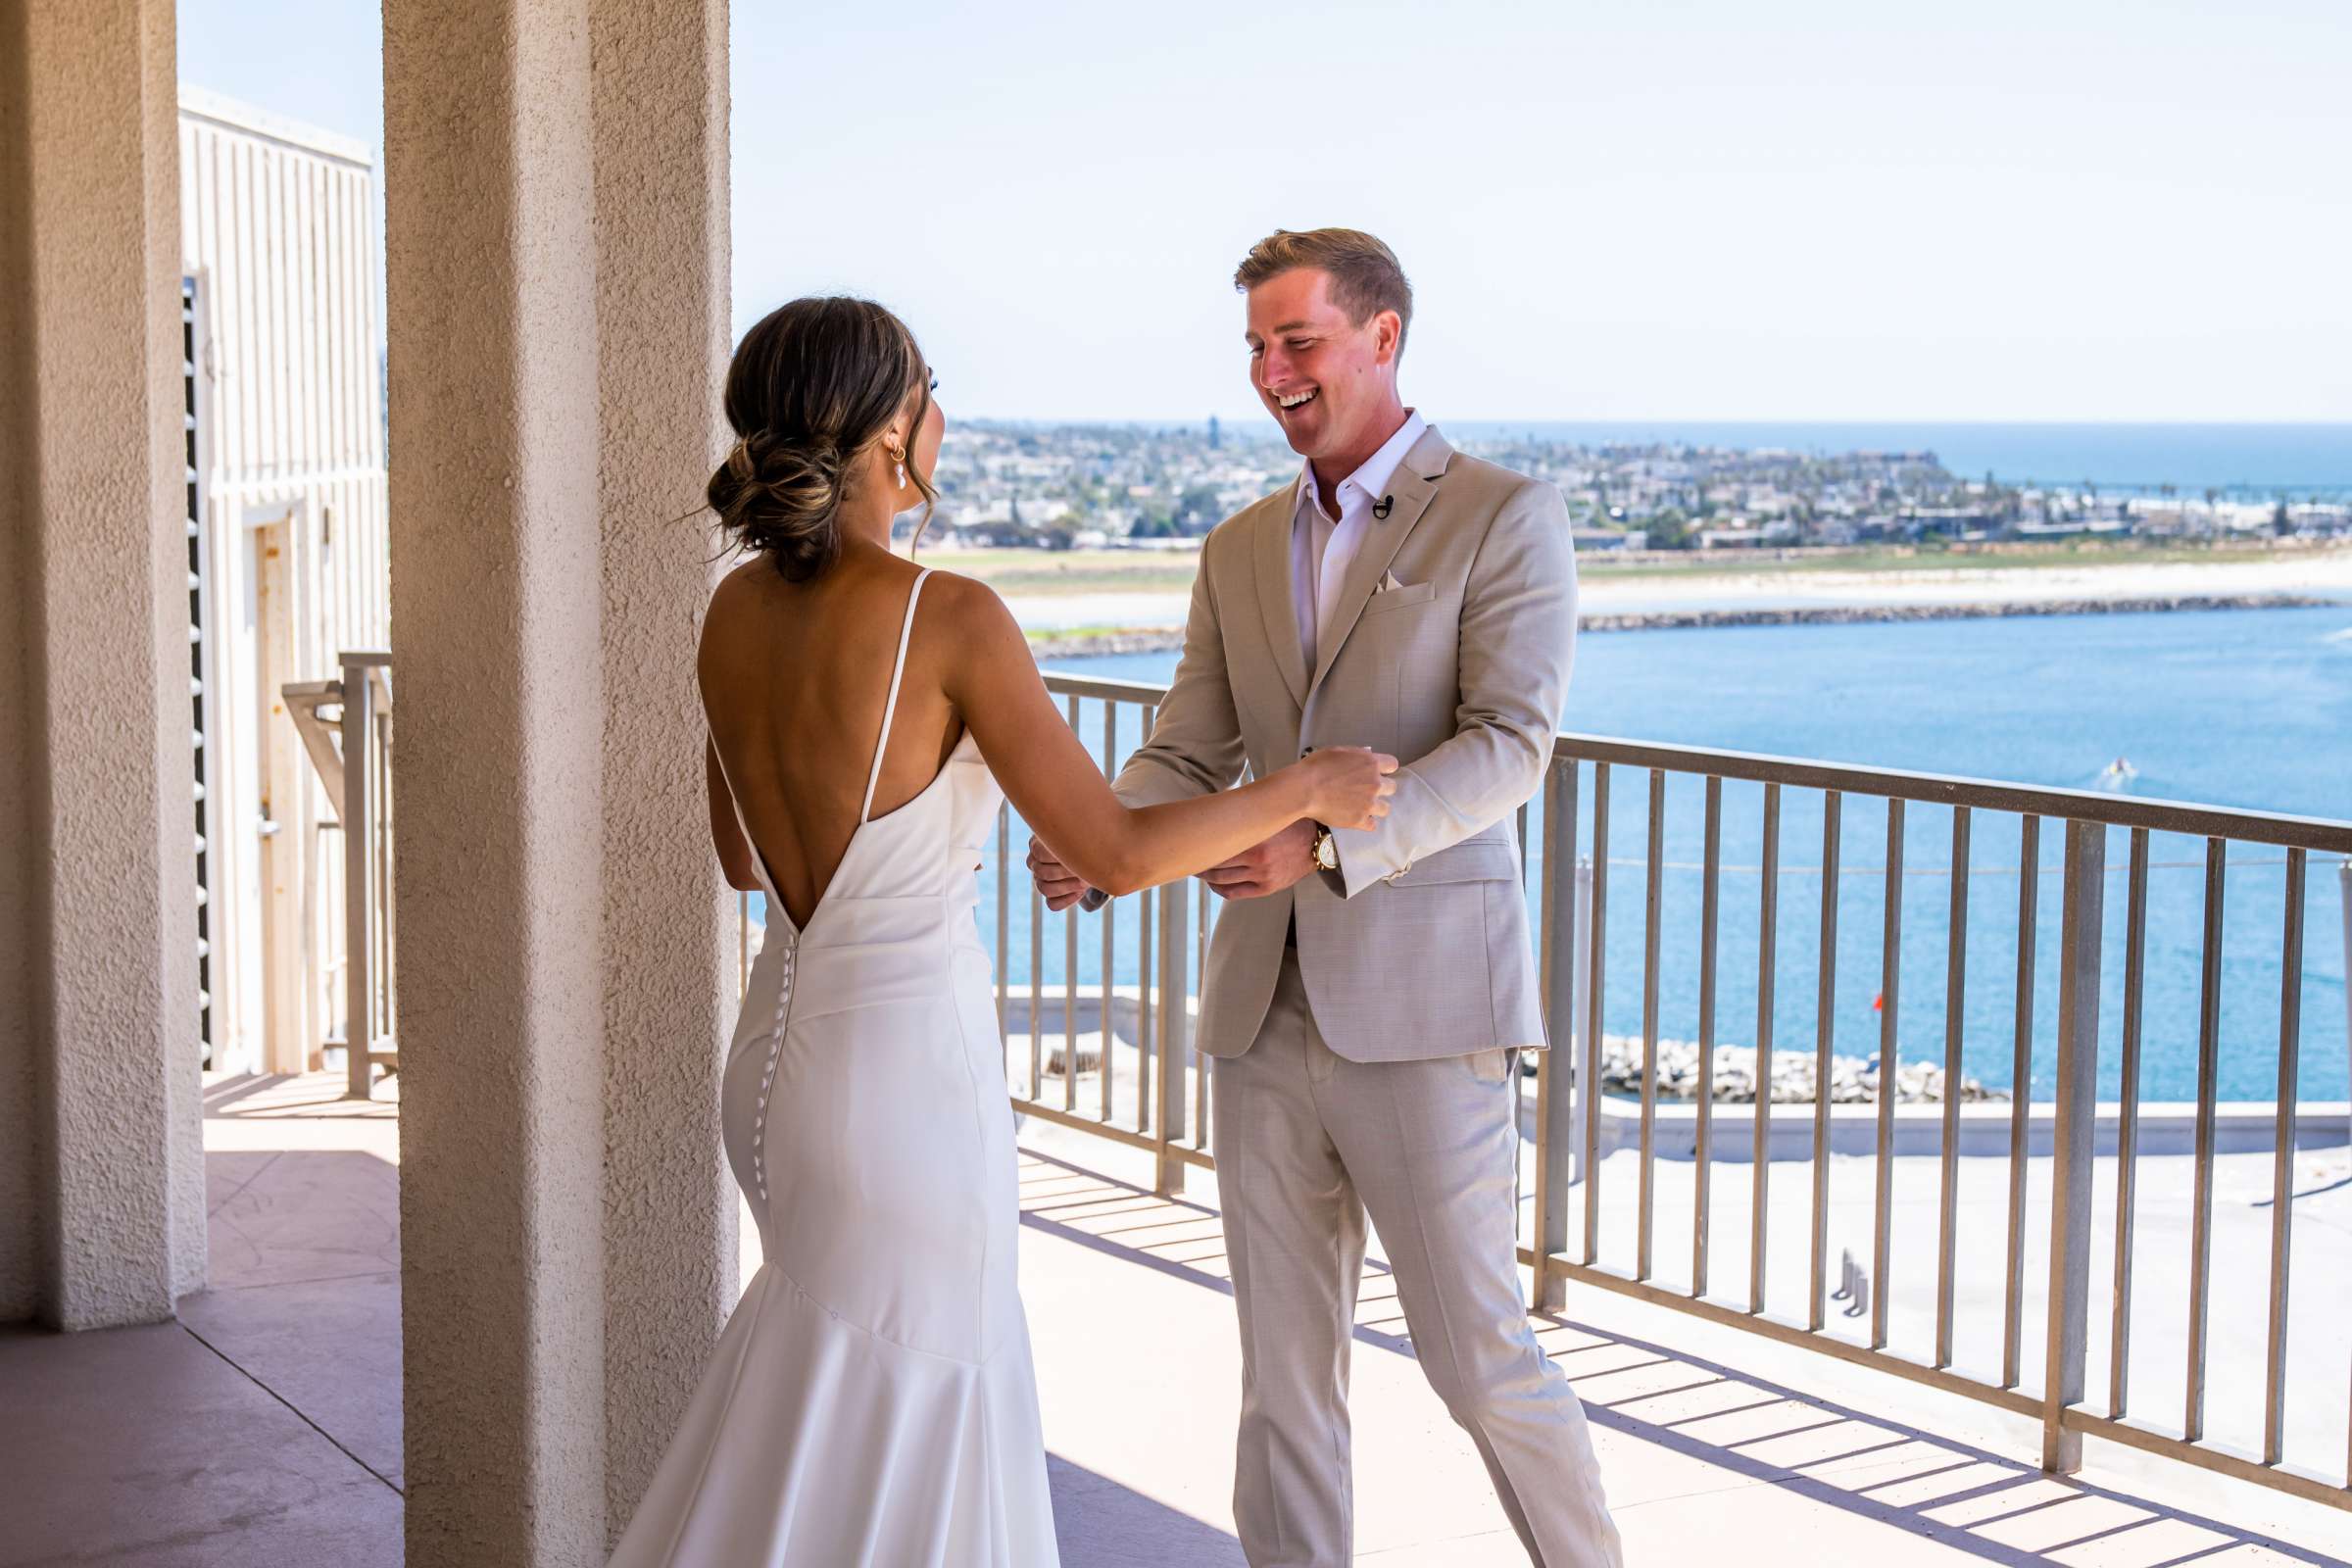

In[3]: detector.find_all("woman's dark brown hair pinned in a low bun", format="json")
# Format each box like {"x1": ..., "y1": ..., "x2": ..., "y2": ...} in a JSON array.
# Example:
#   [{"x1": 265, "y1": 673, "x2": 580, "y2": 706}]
[{"x1": 706, "y1": 296, "x2": 939, "y2": 583}]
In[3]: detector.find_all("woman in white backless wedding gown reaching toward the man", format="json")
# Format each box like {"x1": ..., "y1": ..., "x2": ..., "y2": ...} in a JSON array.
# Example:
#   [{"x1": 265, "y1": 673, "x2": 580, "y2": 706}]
[{"x1": 612, "y1": 299, "x2": 1395, "y2": 1568}]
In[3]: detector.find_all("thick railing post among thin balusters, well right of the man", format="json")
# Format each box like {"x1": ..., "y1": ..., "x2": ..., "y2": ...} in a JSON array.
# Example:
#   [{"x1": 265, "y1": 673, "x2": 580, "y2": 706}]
[{"x1": 2041, "y1": 820, "x2": 2107, "y2": 1474}]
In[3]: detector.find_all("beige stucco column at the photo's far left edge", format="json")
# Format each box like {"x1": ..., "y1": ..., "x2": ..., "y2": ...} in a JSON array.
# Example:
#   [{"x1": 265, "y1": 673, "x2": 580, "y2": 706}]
[{"x1": 0, "y1": 0, "x2": 205, "y2": 1328}]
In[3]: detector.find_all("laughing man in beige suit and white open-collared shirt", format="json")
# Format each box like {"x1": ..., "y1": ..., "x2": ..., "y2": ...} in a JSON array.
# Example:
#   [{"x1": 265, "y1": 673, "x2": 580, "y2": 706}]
[{"x1": 1030, "y1": 228, "x2": 1621, "y2": 1568}]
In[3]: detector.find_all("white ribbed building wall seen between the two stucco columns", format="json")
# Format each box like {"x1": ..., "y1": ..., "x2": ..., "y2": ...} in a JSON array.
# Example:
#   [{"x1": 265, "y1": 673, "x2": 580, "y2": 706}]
[{"x1": 178, "y1": 84, "x2": 390, "y2": 1072}]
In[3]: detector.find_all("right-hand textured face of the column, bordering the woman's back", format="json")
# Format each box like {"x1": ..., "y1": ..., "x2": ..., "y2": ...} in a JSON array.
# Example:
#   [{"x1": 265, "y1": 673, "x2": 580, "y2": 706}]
[{"x1": 590, "y1": 0, "x2": 739, "y2": 1535}]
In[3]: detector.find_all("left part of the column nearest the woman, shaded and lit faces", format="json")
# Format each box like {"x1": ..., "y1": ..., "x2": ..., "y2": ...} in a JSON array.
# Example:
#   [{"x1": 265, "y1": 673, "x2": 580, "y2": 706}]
[{"x1": 383, "y1": 0, "x2": 607, "y2": 1568}]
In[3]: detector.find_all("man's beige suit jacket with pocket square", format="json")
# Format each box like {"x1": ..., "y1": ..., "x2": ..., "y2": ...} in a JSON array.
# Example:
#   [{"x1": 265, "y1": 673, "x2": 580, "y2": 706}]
[{"x1": 1115, "y1": 428, "x2": 1576, "y2": 1062}]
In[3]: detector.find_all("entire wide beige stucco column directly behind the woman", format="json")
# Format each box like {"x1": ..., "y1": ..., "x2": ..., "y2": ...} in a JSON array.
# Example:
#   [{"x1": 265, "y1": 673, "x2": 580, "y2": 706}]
[{"x1": 383, "y1": 0, "x2": 736, "y2": 1568}]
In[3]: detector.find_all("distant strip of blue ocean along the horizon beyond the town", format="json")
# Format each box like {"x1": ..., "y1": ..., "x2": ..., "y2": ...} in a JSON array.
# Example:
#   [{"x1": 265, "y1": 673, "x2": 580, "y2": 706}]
[{"x1": 1442, "y1": 418, "x2": 2352, "y2": 496}]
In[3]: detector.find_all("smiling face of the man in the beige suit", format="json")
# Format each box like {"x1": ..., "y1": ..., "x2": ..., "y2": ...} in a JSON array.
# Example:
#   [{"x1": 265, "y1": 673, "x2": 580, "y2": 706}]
[{"x1": 1249, "y1": 268, "x2": 1401, "y2": 459}]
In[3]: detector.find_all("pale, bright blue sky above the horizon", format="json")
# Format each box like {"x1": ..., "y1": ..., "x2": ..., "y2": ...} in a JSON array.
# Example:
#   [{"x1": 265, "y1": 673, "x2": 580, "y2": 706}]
[{"x1": 178, "y1": 0, "x2": 2352, "y2": 420}]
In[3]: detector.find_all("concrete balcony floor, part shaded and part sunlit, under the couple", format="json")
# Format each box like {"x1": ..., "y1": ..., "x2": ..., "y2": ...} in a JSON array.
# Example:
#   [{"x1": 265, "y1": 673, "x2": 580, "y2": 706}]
[{"x1": 0, "y1": 1077, "x2": 2352, "y2": 1568}]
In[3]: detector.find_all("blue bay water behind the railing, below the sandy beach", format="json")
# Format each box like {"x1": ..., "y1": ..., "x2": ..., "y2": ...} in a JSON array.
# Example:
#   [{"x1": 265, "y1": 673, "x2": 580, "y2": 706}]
[{"x1": 945, "y1": 607, "x2": 2352, "y2": 1101}]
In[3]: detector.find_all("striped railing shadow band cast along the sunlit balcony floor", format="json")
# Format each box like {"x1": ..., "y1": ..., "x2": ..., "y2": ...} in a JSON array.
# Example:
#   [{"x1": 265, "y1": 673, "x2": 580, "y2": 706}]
[{"x1": 1021, "y1": 1145, "x2": 2342, "y2": 1568}]
